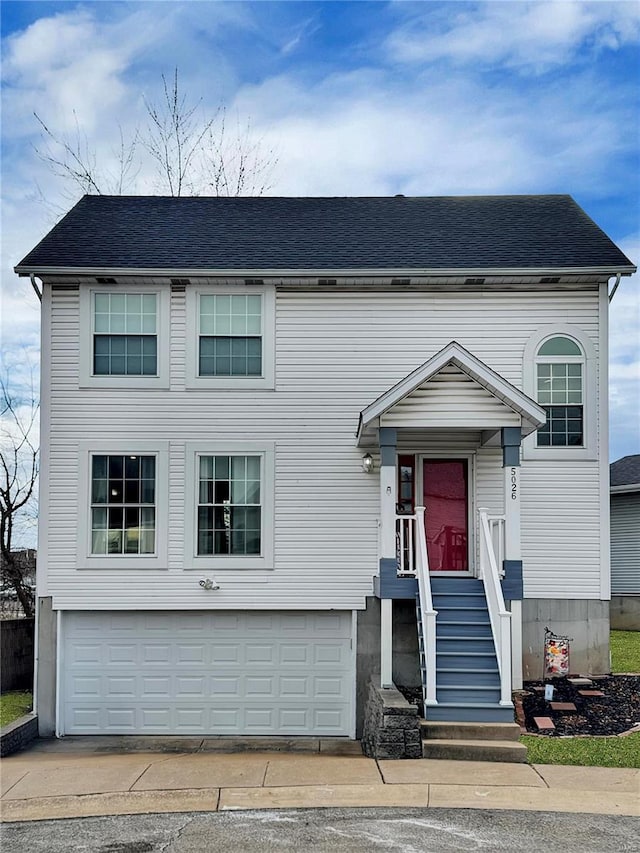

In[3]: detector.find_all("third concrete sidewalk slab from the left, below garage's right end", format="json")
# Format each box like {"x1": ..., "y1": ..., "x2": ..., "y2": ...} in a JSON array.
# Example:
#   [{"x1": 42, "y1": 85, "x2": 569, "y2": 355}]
[{"x1": 264, "y1": 755, "x2": 382, "y2": 787}]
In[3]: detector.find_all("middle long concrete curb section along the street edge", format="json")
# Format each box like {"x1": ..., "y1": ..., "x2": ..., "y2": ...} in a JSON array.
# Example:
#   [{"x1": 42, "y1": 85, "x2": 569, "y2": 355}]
[{"x1": 219, "y1": 785, "x2": 429, "y2": 811}]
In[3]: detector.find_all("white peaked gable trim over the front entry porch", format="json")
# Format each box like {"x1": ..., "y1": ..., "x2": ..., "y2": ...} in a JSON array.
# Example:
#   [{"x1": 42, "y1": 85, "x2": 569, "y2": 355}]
[{"x1": 357, "y1": 341, "x2": 546, "y2": 443}]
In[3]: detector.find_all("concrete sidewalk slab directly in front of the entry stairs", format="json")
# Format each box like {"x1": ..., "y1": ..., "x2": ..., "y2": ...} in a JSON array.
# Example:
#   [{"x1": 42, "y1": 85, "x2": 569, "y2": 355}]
[{"x1": 379, "y1": 759, "x2": 544, "y2": 787}]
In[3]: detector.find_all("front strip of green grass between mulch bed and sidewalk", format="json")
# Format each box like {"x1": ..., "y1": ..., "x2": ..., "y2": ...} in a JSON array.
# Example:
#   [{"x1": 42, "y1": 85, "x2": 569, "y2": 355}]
[{"x1": 520, "y1": 732, "x2": 640, "y2": 767}]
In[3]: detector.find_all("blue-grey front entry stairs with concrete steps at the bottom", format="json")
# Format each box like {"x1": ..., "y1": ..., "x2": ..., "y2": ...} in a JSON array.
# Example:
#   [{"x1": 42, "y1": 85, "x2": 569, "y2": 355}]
[{"x1": 416, "y1": 575, "x2": 527, "y2": 762}]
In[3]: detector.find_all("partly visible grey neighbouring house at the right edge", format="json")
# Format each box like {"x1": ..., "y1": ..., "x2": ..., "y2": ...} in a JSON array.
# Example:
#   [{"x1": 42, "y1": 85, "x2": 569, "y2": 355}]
[{"x1": 609, "y1": 453, "x2": 640, "y2": 631}]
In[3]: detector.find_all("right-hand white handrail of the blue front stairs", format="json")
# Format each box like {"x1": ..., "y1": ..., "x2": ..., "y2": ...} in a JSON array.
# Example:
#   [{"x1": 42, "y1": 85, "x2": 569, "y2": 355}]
[{"x1": 478, "y1": 509, "x2": 512, "y2": 706}]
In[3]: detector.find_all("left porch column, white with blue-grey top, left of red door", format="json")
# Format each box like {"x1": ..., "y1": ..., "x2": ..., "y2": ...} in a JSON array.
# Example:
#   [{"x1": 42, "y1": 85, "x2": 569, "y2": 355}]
[{"x1": 378, "y1": 427, "x2": 397, "y2": 687}]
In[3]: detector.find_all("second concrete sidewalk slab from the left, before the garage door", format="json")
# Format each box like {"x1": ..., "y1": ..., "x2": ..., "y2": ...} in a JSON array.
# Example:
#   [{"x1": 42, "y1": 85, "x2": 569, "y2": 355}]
[{"x1": 133, "y1": 753, "x2": 269, "y2": 791}]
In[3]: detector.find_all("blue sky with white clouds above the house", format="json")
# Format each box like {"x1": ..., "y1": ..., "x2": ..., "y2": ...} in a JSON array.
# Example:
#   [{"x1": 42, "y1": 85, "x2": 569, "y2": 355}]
[{"x1": 0, "y1": 0, "x2": 640, "y2": 486}]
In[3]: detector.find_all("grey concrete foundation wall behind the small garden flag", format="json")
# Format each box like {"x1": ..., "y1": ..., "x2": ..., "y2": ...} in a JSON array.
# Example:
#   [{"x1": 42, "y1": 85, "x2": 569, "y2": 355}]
[{"x1": 522, "y1": 598, "x2": 611, "y2": 681}]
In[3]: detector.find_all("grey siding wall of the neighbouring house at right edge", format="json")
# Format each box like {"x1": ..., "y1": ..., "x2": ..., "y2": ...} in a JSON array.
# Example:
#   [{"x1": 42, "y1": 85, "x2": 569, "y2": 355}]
[{"x1": 611, "y1": 492, "x2": 640, "y2": 595}]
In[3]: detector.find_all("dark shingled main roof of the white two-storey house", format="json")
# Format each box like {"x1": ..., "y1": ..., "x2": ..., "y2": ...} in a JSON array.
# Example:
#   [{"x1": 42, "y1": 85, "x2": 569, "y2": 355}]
[{"x1": 16, "y1": 195, "x2": 635, "y2": 275}]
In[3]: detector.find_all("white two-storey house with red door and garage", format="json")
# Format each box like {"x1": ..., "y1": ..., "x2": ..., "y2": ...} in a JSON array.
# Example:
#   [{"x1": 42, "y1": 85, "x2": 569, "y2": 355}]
[{"x1": 16, "y1": 195, "x2": 635, "y2": 737}]
